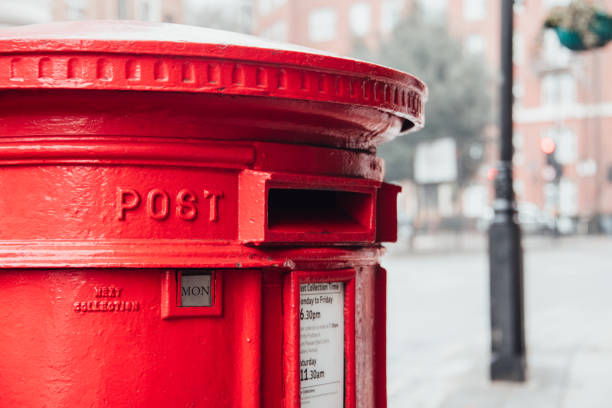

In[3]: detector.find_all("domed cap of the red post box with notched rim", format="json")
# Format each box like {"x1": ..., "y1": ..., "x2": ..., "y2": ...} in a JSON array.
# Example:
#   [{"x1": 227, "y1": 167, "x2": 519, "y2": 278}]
[{"x1": 0, "y1": 21, "x2": 427, "y2": 130}]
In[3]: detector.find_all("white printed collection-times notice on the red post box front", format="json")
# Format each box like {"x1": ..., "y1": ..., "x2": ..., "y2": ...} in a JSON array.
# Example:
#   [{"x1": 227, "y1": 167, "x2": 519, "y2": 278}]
[{"x1": 300, "y1": 282, "x2": 344, "y2": 408}]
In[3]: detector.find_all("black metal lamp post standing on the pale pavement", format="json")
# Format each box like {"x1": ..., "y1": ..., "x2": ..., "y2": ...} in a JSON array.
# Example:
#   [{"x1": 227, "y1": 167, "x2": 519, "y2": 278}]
[{"x1": 489, "y1": 0, "x2": 527, "y2": 381}]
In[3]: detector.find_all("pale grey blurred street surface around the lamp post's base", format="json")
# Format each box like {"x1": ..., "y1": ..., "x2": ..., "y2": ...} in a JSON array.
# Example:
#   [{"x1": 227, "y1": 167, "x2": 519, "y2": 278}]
[{"x1": 383, "y1": 234, "x2": 612, "y2": 408}]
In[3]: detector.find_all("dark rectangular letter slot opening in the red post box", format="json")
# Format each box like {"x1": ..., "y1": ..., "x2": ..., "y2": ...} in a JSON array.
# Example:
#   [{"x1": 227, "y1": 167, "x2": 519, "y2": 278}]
[{"x1": 268, "y1": 188, "x2": 372, "y2": 233}]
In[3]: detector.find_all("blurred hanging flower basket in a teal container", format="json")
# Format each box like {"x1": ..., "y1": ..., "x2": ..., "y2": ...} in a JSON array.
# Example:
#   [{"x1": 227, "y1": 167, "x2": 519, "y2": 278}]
[{"x1": 544, "y1": 0, "x2": 612, "y2": 51}]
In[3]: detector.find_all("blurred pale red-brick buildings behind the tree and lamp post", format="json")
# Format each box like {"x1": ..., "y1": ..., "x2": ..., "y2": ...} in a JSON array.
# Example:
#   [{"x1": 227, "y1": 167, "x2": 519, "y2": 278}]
[{"x1": 253, "y1": 0, "x2": 612, "y2": 232}]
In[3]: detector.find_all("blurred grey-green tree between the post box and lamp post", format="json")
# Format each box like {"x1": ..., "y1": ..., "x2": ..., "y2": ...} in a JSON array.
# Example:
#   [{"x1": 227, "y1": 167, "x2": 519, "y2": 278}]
[{"x1": 360, "y1": 11, "x2": 492, "y2": 185}]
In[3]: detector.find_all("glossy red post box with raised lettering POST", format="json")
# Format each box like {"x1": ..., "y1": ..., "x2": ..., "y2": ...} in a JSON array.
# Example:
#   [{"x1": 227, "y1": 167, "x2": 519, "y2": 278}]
[{"x1": 0, "y1": 22, "x2": 426, "y2": 408}]
